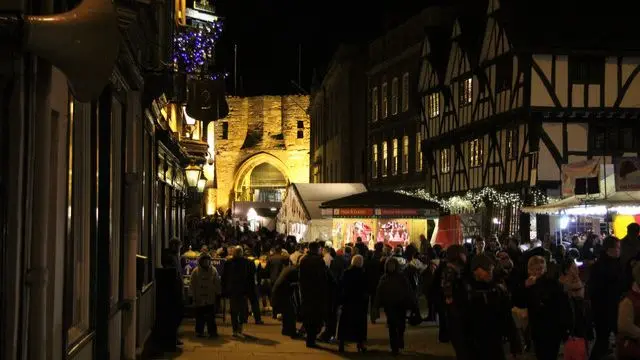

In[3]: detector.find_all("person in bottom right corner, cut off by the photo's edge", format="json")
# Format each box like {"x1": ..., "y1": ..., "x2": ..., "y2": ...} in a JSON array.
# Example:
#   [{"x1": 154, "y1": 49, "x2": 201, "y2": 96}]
[{"x1": 616, "y1": 263, "x2": 640, "y2": 360}]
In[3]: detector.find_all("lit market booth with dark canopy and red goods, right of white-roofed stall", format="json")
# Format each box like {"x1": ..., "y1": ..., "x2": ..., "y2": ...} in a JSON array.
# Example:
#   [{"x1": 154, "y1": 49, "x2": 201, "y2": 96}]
[{"x1": 320, "y1": 191, "x2": 440, "y2": 248}]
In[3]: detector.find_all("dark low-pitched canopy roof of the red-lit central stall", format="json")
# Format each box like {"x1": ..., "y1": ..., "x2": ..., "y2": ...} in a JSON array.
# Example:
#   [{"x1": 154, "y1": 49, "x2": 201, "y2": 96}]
[{"x1": 320, "y1": 191, "x2": 440, "y2": 216}]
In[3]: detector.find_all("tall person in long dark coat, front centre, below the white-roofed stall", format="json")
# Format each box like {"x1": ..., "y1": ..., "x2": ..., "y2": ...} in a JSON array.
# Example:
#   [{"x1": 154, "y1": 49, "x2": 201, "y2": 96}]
[{"x1": 299, "y1": 242, "x2": 331, "y2": 348}]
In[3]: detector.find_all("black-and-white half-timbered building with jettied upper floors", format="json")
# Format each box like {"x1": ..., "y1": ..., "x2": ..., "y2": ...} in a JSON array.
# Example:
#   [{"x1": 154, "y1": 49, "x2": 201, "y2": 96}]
[{"x1": 419, "y1": 0, "x2": 640, "y2": 238}]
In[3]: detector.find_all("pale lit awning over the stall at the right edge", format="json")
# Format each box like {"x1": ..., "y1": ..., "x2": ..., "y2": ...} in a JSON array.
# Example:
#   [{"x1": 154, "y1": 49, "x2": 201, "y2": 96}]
[{"x1": 521, "y1": 191, "x2": 640, "y2": 214}]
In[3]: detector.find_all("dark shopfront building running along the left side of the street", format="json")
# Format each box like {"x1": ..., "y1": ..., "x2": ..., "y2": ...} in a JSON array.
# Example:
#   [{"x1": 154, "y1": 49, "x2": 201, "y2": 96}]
[{"x1": 0, "y1": 0, "x2": 198, "y2": 360}]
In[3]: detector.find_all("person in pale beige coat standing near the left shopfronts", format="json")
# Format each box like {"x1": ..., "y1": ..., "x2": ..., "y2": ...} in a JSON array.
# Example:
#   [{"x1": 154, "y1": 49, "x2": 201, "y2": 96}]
[{"x1": 191, "y1": 252, "x2": 222, "y2": 337}]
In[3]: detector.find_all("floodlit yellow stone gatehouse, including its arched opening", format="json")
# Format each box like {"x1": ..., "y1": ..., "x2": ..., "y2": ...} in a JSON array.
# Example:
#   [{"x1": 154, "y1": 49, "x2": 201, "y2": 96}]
[{"x1": 214, "y1": 95, "x2": 310, "y2": 219}]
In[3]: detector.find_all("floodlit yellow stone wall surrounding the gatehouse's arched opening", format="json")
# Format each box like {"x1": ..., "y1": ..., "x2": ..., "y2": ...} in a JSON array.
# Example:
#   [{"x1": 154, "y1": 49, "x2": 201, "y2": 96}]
[{"x1": 215, "y1": 95, "x2": 310, "y2": 210}]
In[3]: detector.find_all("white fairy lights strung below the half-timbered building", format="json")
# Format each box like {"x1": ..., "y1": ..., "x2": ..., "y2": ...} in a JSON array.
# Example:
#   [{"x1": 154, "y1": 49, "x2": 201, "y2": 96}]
[{"x1": 397, "y1": 187, "x2": 552, "y2": 213}]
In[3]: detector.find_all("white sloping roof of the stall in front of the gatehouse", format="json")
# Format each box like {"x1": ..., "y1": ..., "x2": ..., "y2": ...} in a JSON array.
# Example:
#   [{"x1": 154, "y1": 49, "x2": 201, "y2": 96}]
[{"x1": 291, "y1": 183, "x2": 367, "y2": 220}]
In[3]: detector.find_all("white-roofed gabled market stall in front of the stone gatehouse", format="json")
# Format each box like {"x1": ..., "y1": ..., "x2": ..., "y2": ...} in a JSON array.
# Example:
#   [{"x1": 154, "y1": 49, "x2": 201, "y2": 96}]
[{"x1": 276, "y1": 183, "x2": 367, "y2": 241}]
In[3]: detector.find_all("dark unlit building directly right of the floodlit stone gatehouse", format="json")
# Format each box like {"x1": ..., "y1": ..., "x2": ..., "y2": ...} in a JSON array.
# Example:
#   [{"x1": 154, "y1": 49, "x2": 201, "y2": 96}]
[{"x1": 309, "y1": 45, "x2": 367, "y2": 183}]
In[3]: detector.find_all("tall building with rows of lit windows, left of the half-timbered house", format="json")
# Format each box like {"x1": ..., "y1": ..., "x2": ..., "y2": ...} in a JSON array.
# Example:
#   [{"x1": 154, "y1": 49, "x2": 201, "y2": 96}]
[{"x1": 367, "y1": 7, "x2": 448, "y2": 190}]
